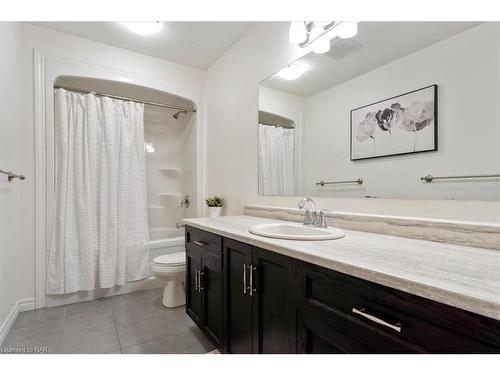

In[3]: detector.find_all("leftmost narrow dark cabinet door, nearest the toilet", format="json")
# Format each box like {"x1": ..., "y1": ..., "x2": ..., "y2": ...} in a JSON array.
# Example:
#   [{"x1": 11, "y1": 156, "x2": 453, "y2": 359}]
[{"x1": 186, "y1": 247, "x2": 202, "y2": 325}]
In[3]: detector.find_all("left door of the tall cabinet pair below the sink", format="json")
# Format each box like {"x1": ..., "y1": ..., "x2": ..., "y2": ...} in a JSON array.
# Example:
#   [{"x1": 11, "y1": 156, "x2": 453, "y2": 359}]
[{"x1": 223, "y1": 238, "x2": 252, "y2": 354}]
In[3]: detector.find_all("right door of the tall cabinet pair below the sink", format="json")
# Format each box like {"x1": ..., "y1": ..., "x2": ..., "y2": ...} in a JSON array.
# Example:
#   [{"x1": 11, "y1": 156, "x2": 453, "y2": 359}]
[{"x1": 250, "y1": 248, "x2": 296, "y2": 354}]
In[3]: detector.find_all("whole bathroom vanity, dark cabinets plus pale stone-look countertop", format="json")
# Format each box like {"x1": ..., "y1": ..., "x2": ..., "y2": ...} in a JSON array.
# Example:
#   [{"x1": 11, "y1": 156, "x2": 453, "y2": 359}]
[{"x1": 185, "y1": 216, "x2": 500, "y2": 353}]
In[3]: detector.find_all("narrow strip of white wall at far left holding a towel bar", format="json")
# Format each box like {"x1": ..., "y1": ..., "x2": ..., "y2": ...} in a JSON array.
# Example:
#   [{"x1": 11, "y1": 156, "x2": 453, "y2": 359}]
[{"x1": 0, "y1": 22, "x2": 23, "y2": 334}]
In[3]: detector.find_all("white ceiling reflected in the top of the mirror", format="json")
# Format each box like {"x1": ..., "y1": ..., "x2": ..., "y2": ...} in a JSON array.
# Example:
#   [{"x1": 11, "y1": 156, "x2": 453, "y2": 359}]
[{"x1": 261, "y1": 22, "x2": 479, "y2": 97}]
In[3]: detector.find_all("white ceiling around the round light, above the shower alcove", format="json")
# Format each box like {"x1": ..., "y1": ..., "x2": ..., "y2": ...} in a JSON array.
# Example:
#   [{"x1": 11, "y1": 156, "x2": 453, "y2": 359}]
[{"x1": 28, "y1": 22, "x2": 253, "y2": 70}]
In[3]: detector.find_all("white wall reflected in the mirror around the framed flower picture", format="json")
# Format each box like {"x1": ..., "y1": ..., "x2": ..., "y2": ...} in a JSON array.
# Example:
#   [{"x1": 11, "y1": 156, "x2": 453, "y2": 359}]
[{"x1": 303, "y1": 23, "x2": 500, "y2": 201}]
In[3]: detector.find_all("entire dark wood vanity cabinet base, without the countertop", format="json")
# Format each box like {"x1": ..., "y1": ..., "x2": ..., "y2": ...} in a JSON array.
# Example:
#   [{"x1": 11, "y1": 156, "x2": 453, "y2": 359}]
[{"x1": 186, "y1": 227, "x2": 500, "y2": 354}]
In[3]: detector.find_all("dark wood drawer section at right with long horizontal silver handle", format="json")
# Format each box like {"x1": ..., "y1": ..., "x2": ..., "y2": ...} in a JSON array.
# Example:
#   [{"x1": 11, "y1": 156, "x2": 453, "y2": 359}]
[{"x1": 296, "y1": 262, "x2": 500, "y2": 353}]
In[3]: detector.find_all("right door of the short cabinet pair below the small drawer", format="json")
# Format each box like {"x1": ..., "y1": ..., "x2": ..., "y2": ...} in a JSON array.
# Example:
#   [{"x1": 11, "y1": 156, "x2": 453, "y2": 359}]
[{"x1": 200, "y1": 253, "x2": 222, "y2": 349}]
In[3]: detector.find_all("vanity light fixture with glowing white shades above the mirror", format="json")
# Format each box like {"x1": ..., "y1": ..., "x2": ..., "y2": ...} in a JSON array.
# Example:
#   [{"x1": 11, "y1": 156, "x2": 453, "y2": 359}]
[{"x1": 289, "y1": 21, "x2": 358, "y2": 53}]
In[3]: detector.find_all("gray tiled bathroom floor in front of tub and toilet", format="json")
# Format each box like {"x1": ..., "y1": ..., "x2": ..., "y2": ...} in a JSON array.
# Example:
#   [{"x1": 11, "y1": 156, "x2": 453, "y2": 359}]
[{"x1": 2, "y1": 288, "x2": 214, "y2": 354}]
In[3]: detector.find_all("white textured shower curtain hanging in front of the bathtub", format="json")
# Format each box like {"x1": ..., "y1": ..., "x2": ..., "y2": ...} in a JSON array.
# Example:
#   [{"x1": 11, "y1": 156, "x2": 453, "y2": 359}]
[{"x1": 47, "y1": 89, "x2": 149, "y2": 294}]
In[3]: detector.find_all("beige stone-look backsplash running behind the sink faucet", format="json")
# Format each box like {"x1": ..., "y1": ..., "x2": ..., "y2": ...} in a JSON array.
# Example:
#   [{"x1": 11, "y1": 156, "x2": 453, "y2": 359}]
[{"x1": 245, "y1": 205, "x2": 500, "y2": 250}]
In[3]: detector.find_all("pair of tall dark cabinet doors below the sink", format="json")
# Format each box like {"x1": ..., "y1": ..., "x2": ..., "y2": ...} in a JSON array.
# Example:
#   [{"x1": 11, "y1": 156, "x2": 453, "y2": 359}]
[{"x1": 223, "y1": 239, "x2": 295, "y2": 354}]
